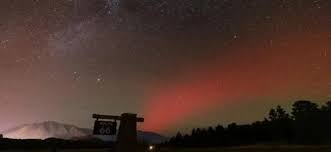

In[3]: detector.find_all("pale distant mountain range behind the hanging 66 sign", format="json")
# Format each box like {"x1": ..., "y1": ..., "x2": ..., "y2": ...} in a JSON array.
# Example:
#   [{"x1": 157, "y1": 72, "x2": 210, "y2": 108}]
[{"x1": 2, "y1": 121, "x2": 167, "y2": 143}]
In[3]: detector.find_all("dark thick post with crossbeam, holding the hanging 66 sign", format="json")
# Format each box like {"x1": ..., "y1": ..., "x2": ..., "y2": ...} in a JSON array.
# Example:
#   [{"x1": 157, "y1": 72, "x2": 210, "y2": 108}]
[{"x1": 93, "y1": 113, "x2": 144, "y2": 152}]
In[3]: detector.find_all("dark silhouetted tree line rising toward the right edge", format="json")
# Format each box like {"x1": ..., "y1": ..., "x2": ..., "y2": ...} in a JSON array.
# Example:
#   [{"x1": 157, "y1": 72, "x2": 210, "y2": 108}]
[{"x1": 167, "y1": 100, "x2": 331, "y2": 147}]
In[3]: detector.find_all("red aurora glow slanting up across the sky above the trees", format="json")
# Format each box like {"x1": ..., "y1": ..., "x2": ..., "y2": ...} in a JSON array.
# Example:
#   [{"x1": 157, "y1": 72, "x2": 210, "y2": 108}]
[{"x1": 144, "y1": 33, "x2": 330, "y2": 131}]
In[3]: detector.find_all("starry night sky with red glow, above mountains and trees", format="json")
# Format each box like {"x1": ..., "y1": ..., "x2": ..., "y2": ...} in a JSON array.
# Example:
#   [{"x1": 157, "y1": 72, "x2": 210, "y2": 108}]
[{"x1": 0, "y1": 0, "x2": 331, "y2": 135}]
